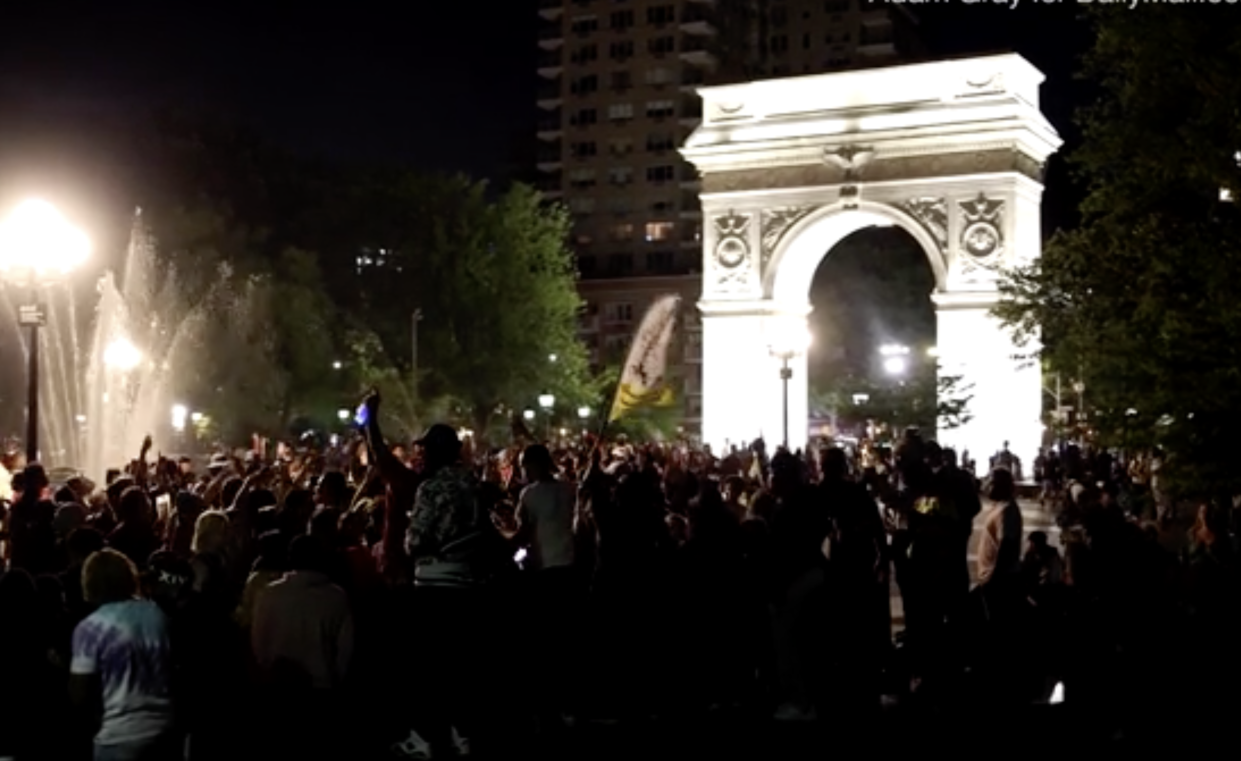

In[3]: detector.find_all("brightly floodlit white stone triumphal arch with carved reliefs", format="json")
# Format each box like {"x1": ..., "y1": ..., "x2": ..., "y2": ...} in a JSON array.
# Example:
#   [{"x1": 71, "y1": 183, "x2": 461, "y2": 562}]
[{"x1": 681, "y1": 55, "x2": 1061, "y2": 463}]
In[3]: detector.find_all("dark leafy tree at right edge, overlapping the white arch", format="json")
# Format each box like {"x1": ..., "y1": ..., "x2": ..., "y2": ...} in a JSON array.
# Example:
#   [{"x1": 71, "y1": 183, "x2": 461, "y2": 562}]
[{"x1": 997, "y1": 6, "x2": 1241, "y2": 494}]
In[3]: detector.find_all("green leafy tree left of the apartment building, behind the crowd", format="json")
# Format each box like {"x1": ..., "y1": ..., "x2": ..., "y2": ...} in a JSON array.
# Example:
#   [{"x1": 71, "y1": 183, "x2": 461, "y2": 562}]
[{"x1": 340, "y1": 174, "x2": 589, "y2": 431}]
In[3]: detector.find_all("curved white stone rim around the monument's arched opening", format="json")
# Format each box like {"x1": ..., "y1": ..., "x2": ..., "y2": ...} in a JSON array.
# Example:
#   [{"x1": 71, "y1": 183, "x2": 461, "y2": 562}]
[{"x1": 762, "y1": 200, "x2": 948, "y2": 302}]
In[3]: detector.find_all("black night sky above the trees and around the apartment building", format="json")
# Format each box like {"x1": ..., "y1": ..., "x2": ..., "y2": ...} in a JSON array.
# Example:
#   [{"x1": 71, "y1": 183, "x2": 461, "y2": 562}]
[{"x1": 0, "y1": 0, "x2": 1085, "y2": 203}]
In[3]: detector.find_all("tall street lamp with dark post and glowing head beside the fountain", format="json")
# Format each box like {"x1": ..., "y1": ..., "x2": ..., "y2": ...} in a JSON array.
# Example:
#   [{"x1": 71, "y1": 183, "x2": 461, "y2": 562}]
[{"x1": 0, "y1": 201, "x2": 91, "y2": 462}]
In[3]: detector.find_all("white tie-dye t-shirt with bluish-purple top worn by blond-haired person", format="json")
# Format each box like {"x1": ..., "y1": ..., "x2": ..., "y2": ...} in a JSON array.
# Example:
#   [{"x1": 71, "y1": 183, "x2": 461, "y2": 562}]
[{"x1": 69, "y1": 600, "x2": 172, "y2": 745}]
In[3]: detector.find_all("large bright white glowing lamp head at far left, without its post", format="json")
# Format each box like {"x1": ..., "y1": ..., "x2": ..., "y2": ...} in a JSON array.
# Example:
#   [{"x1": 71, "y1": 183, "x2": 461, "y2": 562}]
[{"x1": 0, "y1": 200, "x2": 91, "y2": 274}]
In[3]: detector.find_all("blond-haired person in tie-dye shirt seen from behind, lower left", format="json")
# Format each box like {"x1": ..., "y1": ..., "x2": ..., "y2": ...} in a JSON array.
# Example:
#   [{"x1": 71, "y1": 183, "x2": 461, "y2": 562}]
[{"x1": 69, "y1": 549, "x2": 179, "y2": 761}]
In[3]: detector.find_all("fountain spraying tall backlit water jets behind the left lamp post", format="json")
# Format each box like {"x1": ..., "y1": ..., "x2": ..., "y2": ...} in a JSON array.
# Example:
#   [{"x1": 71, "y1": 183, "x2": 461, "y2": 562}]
[{"x1": 4, "y1": 210, "x2": 264, "y2": 483}]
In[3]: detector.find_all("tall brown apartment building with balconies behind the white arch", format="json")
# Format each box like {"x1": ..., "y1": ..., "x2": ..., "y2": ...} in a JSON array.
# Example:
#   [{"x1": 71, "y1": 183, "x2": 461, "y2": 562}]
[{"x1": 536, "y1": 0, "x2": 921, "y2": 431}]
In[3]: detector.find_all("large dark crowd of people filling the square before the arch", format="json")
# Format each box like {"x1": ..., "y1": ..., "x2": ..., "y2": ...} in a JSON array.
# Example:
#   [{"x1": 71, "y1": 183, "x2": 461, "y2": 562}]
[{"x1": 0, "y1": 395, "x2": 1241, "y2": 761}]
